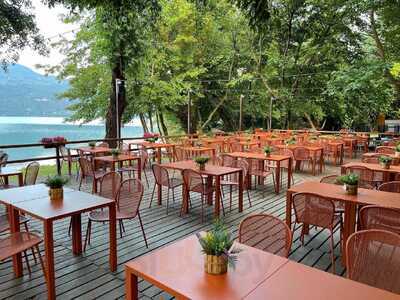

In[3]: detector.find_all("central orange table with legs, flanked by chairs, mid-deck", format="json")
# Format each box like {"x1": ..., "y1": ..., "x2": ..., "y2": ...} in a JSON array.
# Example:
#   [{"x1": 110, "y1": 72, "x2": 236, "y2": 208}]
[{"x1": 158, "y1": 160, "x2": 243, "y2": 217}]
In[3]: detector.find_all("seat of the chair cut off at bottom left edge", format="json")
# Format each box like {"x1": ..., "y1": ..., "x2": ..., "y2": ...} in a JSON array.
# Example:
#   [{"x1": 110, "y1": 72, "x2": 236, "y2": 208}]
[{"x1": 0, "y1": 232, "x2": 42, "y2": 260}]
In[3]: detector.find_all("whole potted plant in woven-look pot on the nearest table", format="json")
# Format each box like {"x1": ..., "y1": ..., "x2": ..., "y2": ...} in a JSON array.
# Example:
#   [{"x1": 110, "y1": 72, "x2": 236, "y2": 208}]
[{"x1": 196, "y1": 219, "x2": 241, "y2": 275}]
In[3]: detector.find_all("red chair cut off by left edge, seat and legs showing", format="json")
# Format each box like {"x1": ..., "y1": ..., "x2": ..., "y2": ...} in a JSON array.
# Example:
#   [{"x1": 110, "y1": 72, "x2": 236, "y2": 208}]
[{"x1": 0, "y1": 232, "x2": 47, "y2": 278}]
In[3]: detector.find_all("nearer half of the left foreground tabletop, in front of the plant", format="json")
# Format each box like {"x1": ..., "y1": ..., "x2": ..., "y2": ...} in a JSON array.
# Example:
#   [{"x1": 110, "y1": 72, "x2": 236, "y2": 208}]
[{"x1": 0, "y1": 187, "x2": 114, "y2": 220}]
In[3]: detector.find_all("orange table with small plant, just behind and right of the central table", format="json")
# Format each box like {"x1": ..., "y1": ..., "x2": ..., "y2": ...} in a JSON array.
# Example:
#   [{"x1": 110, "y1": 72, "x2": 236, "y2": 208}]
[{"x1": 228, "y1": 152, "x2": 293, "y2": 194}]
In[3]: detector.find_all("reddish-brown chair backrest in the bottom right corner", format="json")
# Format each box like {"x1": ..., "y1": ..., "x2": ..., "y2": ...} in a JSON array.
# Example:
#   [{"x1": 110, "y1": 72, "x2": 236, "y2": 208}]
[{"x1": 346, "y1": 229, "x2": 400, "y2": 294}]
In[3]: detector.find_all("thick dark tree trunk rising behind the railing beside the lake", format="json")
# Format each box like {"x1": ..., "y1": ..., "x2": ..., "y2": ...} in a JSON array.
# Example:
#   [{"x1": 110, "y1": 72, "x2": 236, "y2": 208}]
[{"x1": 106, "y1": 57, "x2": 126, "y2": 147}]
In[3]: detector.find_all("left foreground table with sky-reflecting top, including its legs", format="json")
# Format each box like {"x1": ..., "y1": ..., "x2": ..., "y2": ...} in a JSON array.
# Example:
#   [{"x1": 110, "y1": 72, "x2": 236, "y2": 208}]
[{"x1": 0, "y1": 185, "x2": 117, "y2": 299}]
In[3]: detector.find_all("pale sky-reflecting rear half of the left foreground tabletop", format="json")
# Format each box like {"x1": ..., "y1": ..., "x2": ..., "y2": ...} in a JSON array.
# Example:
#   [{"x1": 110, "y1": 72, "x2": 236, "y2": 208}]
[{"x1": 0, "y1": 184, "x2": 74, "y2": 204}]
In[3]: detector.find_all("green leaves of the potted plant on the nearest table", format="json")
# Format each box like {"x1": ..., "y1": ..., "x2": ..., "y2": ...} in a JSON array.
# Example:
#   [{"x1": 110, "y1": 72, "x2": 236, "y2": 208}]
[{"x1": 196, "y1": 219, "x2": 240, "y2": 267}]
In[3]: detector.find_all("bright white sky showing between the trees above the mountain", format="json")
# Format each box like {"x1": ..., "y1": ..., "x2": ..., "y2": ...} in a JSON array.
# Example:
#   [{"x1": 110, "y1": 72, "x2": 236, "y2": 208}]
[{"x1": 18, "y1": 0, "x2": 77, "y2": 73}]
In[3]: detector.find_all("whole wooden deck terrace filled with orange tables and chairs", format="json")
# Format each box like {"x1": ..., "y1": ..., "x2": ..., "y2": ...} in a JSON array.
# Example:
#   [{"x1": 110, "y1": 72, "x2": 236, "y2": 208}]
[{"x1": 0, "y1": 129, "x2": 400, "y2": 299}]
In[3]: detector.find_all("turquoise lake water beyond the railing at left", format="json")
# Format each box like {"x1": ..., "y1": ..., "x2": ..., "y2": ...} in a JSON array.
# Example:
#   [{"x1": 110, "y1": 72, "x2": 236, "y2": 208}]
[{"x1": 0, "y1": 117, "x2": 143, "y2": 160}]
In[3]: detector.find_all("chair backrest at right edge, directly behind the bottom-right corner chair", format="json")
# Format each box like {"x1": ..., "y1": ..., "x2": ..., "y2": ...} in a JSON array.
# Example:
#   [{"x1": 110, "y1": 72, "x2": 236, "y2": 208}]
[{"x1": 360, "y1": 205, "x2": 400, "y2": 235}]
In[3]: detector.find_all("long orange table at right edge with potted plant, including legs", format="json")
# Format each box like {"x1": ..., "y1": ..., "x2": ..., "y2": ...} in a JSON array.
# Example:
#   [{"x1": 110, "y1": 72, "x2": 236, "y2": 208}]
[{"x1": 286, "y1": 181, "x2": 400, "y2": 263}]
